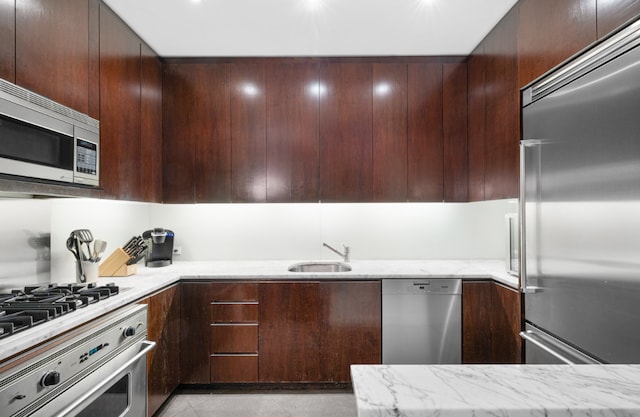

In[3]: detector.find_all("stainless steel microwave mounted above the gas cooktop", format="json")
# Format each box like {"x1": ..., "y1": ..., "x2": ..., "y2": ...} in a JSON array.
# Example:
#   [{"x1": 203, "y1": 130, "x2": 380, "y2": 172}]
[{"x1": 0, "y1": 79, "x2": 100, "y2": 187}]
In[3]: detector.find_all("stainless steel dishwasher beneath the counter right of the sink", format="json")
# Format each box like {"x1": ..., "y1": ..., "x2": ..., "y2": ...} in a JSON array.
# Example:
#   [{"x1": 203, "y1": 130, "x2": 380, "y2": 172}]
[{"x1": 382, "y1": 278, "x2": 462, "y2": 364}]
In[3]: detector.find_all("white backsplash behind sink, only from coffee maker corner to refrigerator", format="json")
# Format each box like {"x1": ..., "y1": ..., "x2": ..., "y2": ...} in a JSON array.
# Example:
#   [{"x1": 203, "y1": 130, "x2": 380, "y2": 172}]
[{"x1": 150, "y1": 200, "x2": 517, "y2": 261}]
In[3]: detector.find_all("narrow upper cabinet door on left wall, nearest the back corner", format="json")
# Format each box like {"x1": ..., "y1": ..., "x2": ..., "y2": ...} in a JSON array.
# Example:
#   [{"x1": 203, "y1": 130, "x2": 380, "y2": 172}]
[{"x1": 140, "y1": 45, "x2": 162, "y2": 203}]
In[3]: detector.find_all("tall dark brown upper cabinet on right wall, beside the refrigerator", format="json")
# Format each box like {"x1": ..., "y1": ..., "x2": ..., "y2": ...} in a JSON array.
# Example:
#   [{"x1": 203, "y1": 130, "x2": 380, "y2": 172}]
[{"x1": 468, "y1": 7, "x2": 520, "y2": 201}]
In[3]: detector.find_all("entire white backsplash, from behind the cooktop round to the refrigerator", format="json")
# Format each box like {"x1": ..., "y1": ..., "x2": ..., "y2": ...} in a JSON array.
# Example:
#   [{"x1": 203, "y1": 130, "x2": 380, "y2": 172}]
[{"x1": 0, "y1": 199, "x2": 517, "y2": 287}]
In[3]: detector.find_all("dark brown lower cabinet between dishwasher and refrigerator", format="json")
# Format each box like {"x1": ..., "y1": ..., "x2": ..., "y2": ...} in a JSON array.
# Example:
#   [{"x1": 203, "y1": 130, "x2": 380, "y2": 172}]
[{"x1": 462, "y1": 281, "x2": 522, "y2": 364}]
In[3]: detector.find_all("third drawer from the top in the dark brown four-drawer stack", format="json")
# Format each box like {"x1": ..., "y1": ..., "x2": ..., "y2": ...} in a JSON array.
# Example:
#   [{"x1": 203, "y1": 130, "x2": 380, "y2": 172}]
[{"x1": 211, "y1": 324, "x2": 258, "y2": 353}]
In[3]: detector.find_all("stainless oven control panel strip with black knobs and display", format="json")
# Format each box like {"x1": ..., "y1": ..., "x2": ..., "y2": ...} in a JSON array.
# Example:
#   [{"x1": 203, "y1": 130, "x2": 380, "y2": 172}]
[{"x1": 0, "y1": 305, "x2": 147, "y2": 415}]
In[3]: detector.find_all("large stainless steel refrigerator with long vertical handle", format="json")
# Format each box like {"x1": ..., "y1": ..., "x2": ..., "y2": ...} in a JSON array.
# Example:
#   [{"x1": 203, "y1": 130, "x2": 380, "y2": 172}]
[{"x1": 520, "y1": 21, "x2": 640, "y2": 363}]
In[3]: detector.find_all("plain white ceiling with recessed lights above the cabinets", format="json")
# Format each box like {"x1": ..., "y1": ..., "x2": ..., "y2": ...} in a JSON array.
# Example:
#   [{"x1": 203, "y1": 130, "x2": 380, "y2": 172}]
[{"x1": 104, "y1": 0, "x2": 517, "y2": 57}]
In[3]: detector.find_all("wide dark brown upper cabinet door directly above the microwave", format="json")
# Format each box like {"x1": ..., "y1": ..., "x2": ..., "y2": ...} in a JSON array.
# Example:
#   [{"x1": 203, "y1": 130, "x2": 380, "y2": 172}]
[{"x1": 15, "y1": 0, "x2": 90, "y2": 113}]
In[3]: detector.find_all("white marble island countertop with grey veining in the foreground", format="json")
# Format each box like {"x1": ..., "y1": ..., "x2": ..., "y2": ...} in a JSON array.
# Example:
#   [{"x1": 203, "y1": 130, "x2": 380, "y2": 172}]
[{"x1": 351, "y1": 365, "x2": 640, "y2": 417}]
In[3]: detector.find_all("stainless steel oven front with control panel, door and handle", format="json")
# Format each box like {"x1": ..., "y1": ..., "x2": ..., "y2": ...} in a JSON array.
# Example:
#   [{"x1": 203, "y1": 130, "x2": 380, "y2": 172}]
[{"x1": 0, "y1": 305, "x2": 155, "y2": 417}]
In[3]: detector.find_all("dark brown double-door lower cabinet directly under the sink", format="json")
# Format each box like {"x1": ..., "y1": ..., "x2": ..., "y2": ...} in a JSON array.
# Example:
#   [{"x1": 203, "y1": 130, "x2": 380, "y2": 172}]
[{"x1": 260, "y1": 281, "x2": 382, "y2": 383}]
